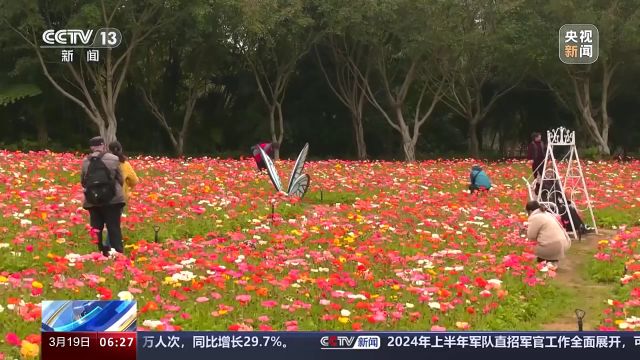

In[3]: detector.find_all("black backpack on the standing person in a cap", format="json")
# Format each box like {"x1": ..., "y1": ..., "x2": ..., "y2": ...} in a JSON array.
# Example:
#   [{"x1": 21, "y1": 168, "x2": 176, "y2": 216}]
[{"x1": 84, "y1": 153, "x2": 116, "y2": 206}]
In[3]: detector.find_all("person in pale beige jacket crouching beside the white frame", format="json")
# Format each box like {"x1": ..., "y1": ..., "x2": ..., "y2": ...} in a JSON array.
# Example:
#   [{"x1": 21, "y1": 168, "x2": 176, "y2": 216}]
[{"x1": 526, "y1": 201, "x2": 571, "y2": 265}]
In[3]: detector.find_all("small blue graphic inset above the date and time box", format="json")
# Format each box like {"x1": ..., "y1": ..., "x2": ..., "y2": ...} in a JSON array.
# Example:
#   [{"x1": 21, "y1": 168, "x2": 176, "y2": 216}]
[{"x1": 42, "y1": 300, "x2": 138, "y2": 332}]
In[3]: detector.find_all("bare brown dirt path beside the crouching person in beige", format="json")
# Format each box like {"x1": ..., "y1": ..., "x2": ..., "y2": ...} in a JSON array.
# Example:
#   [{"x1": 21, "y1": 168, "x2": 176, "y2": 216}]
[{"x1": 541, "y1": 230, "x2": 616, "y2": 331}]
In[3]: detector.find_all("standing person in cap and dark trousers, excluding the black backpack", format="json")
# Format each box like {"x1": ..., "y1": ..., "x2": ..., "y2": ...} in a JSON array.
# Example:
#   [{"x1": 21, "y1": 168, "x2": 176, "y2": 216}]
[{"x1": 81, "y1": 136, "x2": 125, "y2": 256}]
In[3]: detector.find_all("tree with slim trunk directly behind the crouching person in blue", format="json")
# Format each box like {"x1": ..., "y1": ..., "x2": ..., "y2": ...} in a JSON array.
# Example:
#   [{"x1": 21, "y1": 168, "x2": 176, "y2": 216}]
[{"x1": 443, "y1": 0, "x2": 526, "y2": 157}]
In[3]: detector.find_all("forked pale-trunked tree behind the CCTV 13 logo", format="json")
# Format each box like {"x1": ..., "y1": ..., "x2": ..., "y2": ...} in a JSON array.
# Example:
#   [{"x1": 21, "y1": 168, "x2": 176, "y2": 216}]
[{"x1": 0, "y1": 0, "x2": 176, "y2": 142}]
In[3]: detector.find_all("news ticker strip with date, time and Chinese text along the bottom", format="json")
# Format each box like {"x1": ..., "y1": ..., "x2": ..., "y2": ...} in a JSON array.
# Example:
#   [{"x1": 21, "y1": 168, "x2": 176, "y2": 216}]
[{"x1": 42, "y1": 332, "x2": 640, "y2": 360}]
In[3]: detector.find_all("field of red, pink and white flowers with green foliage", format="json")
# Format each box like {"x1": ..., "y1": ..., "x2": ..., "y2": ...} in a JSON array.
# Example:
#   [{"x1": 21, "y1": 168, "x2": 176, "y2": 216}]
[{"x1": 0, "y1": 151, "x2": 640, "y2": 359}]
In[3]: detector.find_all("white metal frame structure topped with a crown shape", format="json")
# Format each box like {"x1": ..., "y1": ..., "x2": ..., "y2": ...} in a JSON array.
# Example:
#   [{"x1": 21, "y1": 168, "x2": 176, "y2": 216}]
[{"x1": 525, "y1": 127, "x2": 598, "y2": 239}]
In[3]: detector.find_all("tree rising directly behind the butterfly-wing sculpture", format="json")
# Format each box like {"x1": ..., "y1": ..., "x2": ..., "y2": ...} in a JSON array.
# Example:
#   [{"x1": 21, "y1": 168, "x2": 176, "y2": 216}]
[{"x1": 225, "y1": 0, "x2": 317, "y2": 160}]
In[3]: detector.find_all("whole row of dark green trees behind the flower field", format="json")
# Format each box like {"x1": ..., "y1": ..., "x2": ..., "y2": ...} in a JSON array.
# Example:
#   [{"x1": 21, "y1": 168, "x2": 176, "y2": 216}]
[{"x1": 0, "y1": 0, "x2": 640, "y2": 161}]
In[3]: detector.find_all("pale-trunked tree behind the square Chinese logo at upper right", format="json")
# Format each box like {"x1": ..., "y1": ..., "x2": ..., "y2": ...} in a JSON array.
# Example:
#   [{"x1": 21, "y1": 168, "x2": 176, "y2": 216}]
[{"x1": 537, "y1": 0, "x2": 640, "y2": 155}]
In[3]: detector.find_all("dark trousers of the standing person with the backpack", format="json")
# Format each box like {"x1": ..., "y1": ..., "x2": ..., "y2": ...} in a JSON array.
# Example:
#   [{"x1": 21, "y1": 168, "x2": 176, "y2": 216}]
[{"x1": 89, "y1": 204, "x2": 124, "y2": 256}]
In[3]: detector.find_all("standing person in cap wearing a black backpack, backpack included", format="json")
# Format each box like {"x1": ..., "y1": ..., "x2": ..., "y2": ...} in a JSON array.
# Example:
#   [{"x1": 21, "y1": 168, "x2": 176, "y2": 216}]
[{"x1": 81, "y1": 136, "x2": 125, "y2": 256}]
